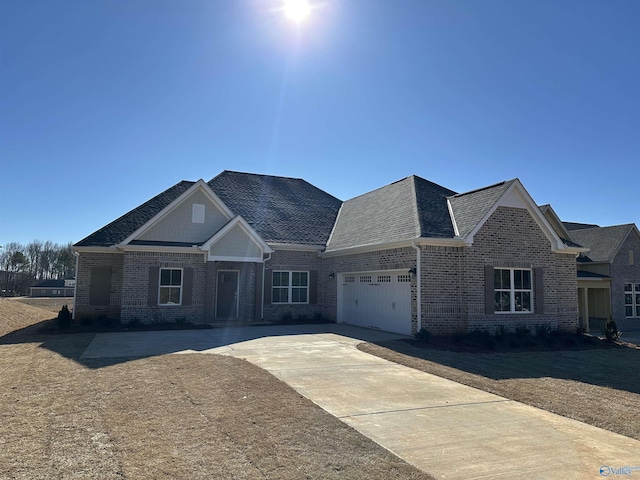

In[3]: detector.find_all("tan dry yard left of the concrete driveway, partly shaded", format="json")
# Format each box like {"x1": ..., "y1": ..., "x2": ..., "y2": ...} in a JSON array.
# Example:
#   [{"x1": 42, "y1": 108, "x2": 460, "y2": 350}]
[{"x1": 0, "y1": 299, "x2": 431, "y2": 479}]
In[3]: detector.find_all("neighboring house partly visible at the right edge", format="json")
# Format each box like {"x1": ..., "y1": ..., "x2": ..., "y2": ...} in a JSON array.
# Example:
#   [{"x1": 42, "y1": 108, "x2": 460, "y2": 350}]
[{"x1": 564, "y1": 222, "x2": 640, "y2": 332}]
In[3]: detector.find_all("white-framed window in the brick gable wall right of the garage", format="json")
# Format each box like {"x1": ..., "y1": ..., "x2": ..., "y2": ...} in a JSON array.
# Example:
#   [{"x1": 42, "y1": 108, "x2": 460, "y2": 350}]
[{"x1": 493, "y1": 268, "x2": 533, "y2": 313}]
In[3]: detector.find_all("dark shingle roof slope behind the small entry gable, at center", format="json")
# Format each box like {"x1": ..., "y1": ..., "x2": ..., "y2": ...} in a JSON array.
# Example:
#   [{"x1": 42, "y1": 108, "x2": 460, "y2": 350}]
[{"x1": 208, "y1": 170, "x2": 342, "y2": 245}]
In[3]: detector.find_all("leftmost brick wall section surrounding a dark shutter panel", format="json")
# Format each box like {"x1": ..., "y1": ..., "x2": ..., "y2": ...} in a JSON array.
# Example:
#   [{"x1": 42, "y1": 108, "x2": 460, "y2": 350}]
[{"x1": 74, "y1": 252, "x2": 124, "y2": 320}]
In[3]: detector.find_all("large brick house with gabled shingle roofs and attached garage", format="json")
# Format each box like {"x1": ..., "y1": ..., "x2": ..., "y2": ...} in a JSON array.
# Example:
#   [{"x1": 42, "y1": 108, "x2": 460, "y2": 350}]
[{"x1": 73, "y1": 171, "x2": 586, "y2": 334}]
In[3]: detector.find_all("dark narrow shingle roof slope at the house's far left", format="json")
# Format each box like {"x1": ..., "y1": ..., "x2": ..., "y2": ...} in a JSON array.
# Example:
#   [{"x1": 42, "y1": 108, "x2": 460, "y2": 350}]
[{"x1": 74, "y1": 181, "x2": 195, "y2": 247}]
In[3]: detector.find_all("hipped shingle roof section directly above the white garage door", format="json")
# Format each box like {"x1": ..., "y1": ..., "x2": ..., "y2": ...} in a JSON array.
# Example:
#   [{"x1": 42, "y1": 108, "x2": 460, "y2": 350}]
[{"x1": 327, "y1": 175, "x2": 455, "y2": 251}]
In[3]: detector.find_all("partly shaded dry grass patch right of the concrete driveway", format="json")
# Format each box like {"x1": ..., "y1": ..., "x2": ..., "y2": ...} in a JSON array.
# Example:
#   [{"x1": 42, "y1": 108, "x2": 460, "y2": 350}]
[{"x1": 358, "y1": 341, "x2": 640, "y2": 440}]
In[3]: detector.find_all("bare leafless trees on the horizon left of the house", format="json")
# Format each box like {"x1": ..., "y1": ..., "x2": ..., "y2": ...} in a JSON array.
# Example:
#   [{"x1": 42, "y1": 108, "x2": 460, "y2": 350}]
[{"x1": 0, "y1": 240, "x2": 76, "y2": 296}]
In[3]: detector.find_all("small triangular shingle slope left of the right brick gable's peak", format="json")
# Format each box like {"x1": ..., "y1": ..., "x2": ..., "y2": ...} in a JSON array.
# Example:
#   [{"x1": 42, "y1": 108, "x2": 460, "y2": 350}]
[{"x1": 449, "y1": 180, "x2": 515, "y2": 238}]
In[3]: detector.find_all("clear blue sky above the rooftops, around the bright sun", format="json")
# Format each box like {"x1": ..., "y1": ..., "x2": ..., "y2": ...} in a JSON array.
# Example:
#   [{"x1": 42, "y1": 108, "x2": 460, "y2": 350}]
[{"x1": 0, "y1": 0, "x2": 640, "y2": 248}]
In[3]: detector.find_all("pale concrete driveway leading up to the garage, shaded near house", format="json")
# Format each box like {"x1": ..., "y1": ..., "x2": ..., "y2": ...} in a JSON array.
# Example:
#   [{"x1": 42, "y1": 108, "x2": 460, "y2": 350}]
[{"x1": 82, "y1": 325, "x2": 640, "y2": 479}]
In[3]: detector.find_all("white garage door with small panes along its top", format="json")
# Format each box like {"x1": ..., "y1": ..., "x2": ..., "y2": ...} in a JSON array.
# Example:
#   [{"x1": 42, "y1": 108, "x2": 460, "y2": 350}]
[{"x1": 338, "y1": 270, "x2": 411, "y2": 335}]
